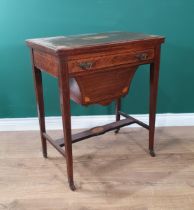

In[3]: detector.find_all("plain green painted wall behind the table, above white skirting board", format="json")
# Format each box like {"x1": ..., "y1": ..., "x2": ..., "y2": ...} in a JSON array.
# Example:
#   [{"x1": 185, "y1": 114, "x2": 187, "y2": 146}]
[{"x1": 0, "y1": 0, "x2": 194, "y2": 117}]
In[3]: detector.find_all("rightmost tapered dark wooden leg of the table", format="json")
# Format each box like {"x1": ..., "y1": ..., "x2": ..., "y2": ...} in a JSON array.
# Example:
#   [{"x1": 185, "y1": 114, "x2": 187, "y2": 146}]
[{"x1": 149, "y1": 47, "x2": 160, "y2": 157}]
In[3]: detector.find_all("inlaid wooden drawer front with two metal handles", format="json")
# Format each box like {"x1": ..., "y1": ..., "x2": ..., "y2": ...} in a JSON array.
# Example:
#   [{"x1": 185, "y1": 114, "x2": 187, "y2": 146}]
[{"x1": 68, "y1": 49, "x2": 154, "y2": 73}]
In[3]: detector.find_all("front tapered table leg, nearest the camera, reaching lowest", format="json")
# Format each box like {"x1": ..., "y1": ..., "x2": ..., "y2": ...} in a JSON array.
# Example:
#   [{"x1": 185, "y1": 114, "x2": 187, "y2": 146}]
[{"x1": 59, "y1": 62, "x2": 75, "y2": 191}]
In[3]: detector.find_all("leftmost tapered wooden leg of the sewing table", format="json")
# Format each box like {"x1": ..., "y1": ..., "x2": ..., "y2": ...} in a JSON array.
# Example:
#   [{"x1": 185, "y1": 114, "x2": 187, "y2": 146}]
[{"x1": 32, "y1": 52, "x2": 47, "y2": 158}]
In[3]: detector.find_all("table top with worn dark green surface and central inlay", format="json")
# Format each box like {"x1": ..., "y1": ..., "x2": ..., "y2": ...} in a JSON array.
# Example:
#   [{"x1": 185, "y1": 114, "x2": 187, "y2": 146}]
[{"x1": 26, "y1": 32, "x2": 164, "y2": 52}]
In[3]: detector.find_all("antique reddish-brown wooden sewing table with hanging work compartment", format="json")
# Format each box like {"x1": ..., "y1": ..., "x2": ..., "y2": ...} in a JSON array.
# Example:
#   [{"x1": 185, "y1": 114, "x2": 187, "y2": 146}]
[{"x1": 26, "y1": 32, "x2": 164, "y2": 190}]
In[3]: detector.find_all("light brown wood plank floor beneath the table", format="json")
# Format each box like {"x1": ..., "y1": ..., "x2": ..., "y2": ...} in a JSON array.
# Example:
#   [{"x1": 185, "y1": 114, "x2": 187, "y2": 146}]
[{"x1": 0, "y1": 127, "x2": 194, "y2": 210}]
